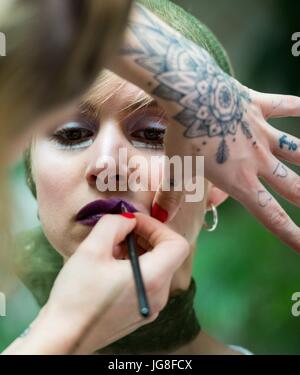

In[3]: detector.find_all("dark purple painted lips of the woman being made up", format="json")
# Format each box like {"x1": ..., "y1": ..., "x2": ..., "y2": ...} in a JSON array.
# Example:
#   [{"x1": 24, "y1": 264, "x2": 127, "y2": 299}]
[{"x1": 75, "y1": 199, "x2": 138, "y2": 226}]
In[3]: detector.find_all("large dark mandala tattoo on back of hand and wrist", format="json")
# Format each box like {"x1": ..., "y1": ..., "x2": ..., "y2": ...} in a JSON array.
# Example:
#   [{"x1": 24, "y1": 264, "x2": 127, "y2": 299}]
[{"x1": 122, "y1": 5, "x2": 252, "y2": 164}]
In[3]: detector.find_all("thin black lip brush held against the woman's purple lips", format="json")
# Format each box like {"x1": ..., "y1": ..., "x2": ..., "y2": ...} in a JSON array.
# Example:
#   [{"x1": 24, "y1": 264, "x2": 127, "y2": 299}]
[{"x1": 121, "y1": 203, "x2": 150, "y2": 317}]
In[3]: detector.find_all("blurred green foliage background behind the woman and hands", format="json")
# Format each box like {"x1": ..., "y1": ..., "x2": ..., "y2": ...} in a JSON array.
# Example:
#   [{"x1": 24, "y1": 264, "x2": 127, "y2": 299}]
[{"x1": 0, "y1": 0, "x2": 300, "y2": 354}]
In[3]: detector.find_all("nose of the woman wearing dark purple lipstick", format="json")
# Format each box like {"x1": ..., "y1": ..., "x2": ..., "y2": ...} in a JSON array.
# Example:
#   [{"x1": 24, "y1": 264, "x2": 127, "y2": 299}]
[{"x1": 85, "y1": 120, "x2": 128, "y2": 191}]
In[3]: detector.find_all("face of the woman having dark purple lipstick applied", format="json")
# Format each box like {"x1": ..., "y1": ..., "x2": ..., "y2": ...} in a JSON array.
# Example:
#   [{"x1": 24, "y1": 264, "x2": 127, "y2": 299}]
[{"x1": 32, "y1": 73, "x2": 203, "y2": 264}]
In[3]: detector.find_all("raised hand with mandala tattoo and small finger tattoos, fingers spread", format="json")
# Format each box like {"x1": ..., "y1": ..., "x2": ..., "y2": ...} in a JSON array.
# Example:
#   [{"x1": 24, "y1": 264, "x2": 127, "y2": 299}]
[{"x1": 113, "y1": 5, "x2": 300, "y2": 251}]
